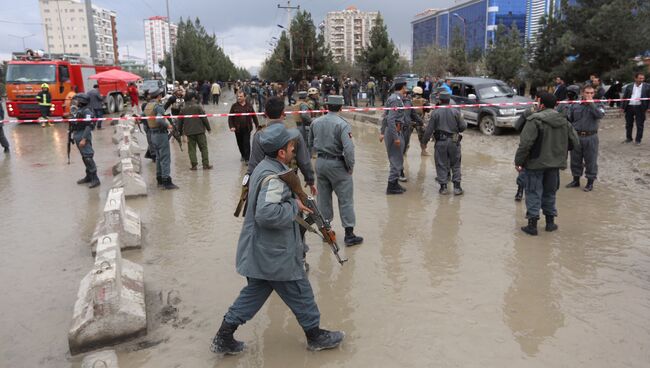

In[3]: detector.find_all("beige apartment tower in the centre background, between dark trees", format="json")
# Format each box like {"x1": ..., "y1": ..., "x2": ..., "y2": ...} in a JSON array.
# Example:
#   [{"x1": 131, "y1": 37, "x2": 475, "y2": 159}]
[{"x1": 320, "y1": 6, "x2": 379, "y2": 63}]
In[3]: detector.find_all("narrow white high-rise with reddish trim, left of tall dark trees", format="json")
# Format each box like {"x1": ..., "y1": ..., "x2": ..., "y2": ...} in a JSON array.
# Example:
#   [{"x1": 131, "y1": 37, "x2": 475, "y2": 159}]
[{"x1": 144, "y1": 16, "x2": 178, "y2": 72}]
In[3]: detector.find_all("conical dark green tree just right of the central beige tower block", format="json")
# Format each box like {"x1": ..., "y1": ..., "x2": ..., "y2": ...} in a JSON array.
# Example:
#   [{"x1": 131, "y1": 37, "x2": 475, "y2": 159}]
[{"x1": 360, "y1": 14, "x2": 400, "y2": 78}]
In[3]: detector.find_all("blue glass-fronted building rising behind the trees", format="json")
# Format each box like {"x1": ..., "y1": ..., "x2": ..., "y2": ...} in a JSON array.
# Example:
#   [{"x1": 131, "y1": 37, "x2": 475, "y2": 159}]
[{"x1": 411, "y1": 0, "x2": 528, "y2": 59}]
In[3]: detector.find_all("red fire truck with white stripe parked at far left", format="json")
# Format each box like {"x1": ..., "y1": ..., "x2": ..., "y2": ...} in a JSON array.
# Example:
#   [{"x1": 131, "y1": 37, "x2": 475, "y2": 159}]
[{"x1": 5, "y1": 50, "x2": 128, "y2": 119}]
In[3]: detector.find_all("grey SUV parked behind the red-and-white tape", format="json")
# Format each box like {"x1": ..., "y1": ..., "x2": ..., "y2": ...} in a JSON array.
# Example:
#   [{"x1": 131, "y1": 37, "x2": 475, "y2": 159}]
[{"x1": 449, "y1": 77, "x2": 531, "y2": 135}]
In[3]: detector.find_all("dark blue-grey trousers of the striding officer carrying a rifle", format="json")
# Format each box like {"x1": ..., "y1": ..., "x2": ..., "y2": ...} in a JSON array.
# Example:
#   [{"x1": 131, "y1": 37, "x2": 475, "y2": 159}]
[{"x1": 224, "y1": 276, "x2": 320, "y2": 331}]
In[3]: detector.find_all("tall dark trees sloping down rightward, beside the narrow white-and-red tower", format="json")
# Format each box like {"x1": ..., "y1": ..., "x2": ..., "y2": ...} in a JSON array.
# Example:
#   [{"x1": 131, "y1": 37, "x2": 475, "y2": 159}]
[{"x1": 162, "y1": 18, "x2": 248, "y2": 81}]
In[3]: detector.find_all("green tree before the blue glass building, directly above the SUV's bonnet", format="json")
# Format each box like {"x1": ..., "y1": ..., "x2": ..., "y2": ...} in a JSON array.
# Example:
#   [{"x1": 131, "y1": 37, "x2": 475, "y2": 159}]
[{"x1": 485, "y1": 24, "x2": 525, "y2": 81}]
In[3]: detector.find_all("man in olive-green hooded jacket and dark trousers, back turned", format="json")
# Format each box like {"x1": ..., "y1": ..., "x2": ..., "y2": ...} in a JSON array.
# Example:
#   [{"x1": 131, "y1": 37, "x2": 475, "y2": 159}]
[{"x1": 515, "y1": 92, "x2": 580, "y2": 235}]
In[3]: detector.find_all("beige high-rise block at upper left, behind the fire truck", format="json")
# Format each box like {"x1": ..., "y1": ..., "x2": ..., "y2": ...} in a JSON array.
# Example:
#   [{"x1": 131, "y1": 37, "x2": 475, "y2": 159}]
[{"x1": 38, "y1": 0, "x2": 119, "y2": 64}]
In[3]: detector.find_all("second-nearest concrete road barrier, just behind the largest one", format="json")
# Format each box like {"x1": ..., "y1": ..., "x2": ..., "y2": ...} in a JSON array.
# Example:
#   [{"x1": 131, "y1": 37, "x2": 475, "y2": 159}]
[{"x1": 91, "y1": 188, "x2": 142, "y2": 249}]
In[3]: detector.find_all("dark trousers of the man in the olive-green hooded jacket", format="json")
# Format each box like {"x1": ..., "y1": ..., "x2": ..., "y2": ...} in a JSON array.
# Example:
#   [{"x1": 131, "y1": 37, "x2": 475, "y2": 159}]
[{"x1": 524, "y1": 169, "x2": 560, "y2": 218}]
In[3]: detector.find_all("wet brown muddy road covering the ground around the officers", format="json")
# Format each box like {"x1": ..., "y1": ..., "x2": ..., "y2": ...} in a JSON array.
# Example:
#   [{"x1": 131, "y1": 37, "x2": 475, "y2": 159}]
[{"x1": 0, "y1": 90, "x2": 650, "y2": 368}]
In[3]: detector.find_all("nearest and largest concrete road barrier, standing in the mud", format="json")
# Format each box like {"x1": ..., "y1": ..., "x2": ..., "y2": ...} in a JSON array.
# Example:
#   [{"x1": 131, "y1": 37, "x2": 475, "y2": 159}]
[{"x1": 68, "y1": 233, "x2": 147, "y2": 355}]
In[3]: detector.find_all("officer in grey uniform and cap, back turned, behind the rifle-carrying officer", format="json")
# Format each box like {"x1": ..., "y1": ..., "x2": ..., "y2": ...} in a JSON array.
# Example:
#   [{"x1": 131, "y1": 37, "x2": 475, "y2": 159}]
[{"x1": 309, "y1": 95, "x2": 363, "y2": 246}]
